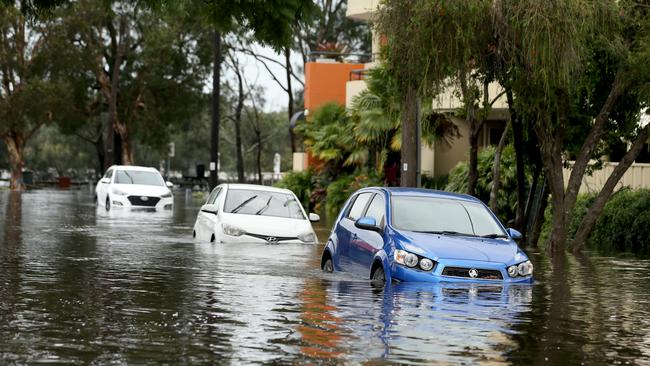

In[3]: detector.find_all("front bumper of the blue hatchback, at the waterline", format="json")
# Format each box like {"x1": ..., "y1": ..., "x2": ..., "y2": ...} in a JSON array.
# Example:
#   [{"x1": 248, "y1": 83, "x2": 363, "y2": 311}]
[{"x1": 390, "y1": 259, "x2": 533, "y2": 284}]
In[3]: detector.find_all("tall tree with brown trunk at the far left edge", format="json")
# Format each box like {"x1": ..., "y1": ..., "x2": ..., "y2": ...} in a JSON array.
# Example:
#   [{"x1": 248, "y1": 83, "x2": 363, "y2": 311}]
[{"x1": 0, "y1": 6, "x2": 71, "y2": 189}]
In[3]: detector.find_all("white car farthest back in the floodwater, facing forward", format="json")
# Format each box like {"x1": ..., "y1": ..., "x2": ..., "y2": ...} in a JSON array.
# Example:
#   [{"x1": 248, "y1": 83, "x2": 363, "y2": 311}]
[{"x1": 95, "y1": 165, "x2": 174, "y2": 210}]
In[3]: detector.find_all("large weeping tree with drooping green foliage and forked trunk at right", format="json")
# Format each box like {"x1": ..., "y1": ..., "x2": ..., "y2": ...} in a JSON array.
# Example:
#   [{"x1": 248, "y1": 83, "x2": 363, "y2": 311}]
[{"x1": 378, "y1": 0, "x2": 650, "y2": 254}]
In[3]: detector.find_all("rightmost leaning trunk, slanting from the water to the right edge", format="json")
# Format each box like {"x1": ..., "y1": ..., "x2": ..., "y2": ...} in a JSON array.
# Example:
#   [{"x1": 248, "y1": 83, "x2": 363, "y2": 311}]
[{"x1": 572, "y1": 125, "x2": 650, "y2": 252}]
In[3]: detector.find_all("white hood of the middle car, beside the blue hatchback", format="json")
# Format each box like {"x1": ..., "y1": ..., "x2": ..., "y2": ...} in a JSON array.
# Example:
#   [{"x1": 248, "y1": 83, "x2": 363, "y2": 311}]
[{"x1": 220, "y1": 213, "x2": 314, "y2": 237}]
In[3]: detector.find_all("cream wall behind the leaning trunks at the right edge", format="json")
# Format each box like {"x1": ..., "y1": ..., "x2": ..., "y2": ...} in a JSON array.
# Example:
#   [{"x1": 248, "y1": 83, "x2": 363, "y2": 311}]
[{"x1": 564, "y1": 163, "x2": 650, "y2": 193}]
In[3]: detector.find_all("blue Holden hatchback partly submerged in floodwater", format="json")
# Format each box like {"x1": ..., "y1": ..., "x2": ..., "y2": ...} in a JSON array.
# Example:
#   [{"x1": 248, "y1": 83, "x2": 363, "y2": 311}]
[{"x1": 321, "y1": 187, "x2": 533, "y2": 283}]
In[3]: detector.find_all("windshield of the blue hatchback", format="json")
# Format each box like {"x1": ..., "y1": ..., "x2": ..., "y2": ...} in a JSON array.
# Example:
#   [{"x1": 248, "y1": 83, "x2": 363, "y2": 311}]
[{"x1": 391, "y1": 196, "x2": 505, "y2": 236}]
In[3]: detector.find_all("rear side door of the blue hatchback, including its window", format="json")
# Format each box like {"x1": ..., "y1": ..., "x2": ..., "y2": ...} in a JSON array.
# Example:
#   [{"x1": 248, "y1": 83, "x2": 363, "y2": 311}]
[{"x1": 335, "y1": 192, "x2": 373, "y2": 272}]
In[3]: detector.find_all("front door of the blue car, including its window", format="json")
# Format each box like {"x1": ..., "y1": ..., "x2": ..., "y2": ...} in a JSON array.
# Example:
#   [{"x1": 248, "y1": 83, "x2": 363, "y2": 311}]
[{"x1": 350, "y1": 193, "x2": 386, "y2": 276}]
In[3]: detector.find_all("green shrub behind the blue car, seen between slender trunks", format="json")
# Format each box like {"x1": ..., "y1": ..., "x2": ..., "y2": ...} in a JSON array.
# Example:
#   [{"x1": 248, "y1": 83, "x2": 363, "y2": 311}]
[{"x1": 445, "y1": 145, "x2": 517, "y2": 224}]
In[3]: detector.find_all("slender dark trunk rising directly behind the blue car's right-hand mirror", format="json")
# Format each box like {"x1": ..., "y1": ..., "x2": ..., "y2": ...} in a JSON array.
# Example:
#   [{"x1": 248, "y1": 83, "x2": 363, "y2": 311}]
[{"x1": 506, "y1": 87, "x2": 527, "y2": 229}]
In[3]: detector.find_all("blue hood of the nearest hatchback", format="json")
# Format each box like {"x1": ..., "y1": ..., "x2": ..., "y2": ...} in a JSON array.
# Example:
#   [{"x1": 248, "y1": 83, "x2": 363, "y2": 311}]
[{"x1": 400, "y1": 231, "x2": 518, "y2": 263}]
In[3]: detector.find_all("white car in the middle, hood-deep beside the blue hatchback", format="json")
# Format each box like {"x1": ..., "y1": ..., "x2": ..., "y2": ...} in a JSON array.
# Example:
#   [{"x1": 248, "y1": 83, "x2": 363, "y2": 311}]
[{"x1": 193, "y1": 184, "x2": 320, "y2": 244}]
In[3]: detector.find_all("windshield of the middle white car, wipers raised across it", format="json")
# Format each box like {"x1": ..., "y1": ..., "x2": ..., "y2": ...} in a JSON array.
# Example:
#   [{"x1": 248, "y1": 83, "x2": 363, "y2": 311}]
[{"x1": 224, "y1": 189, "x2": 305, "y2": 219}]
